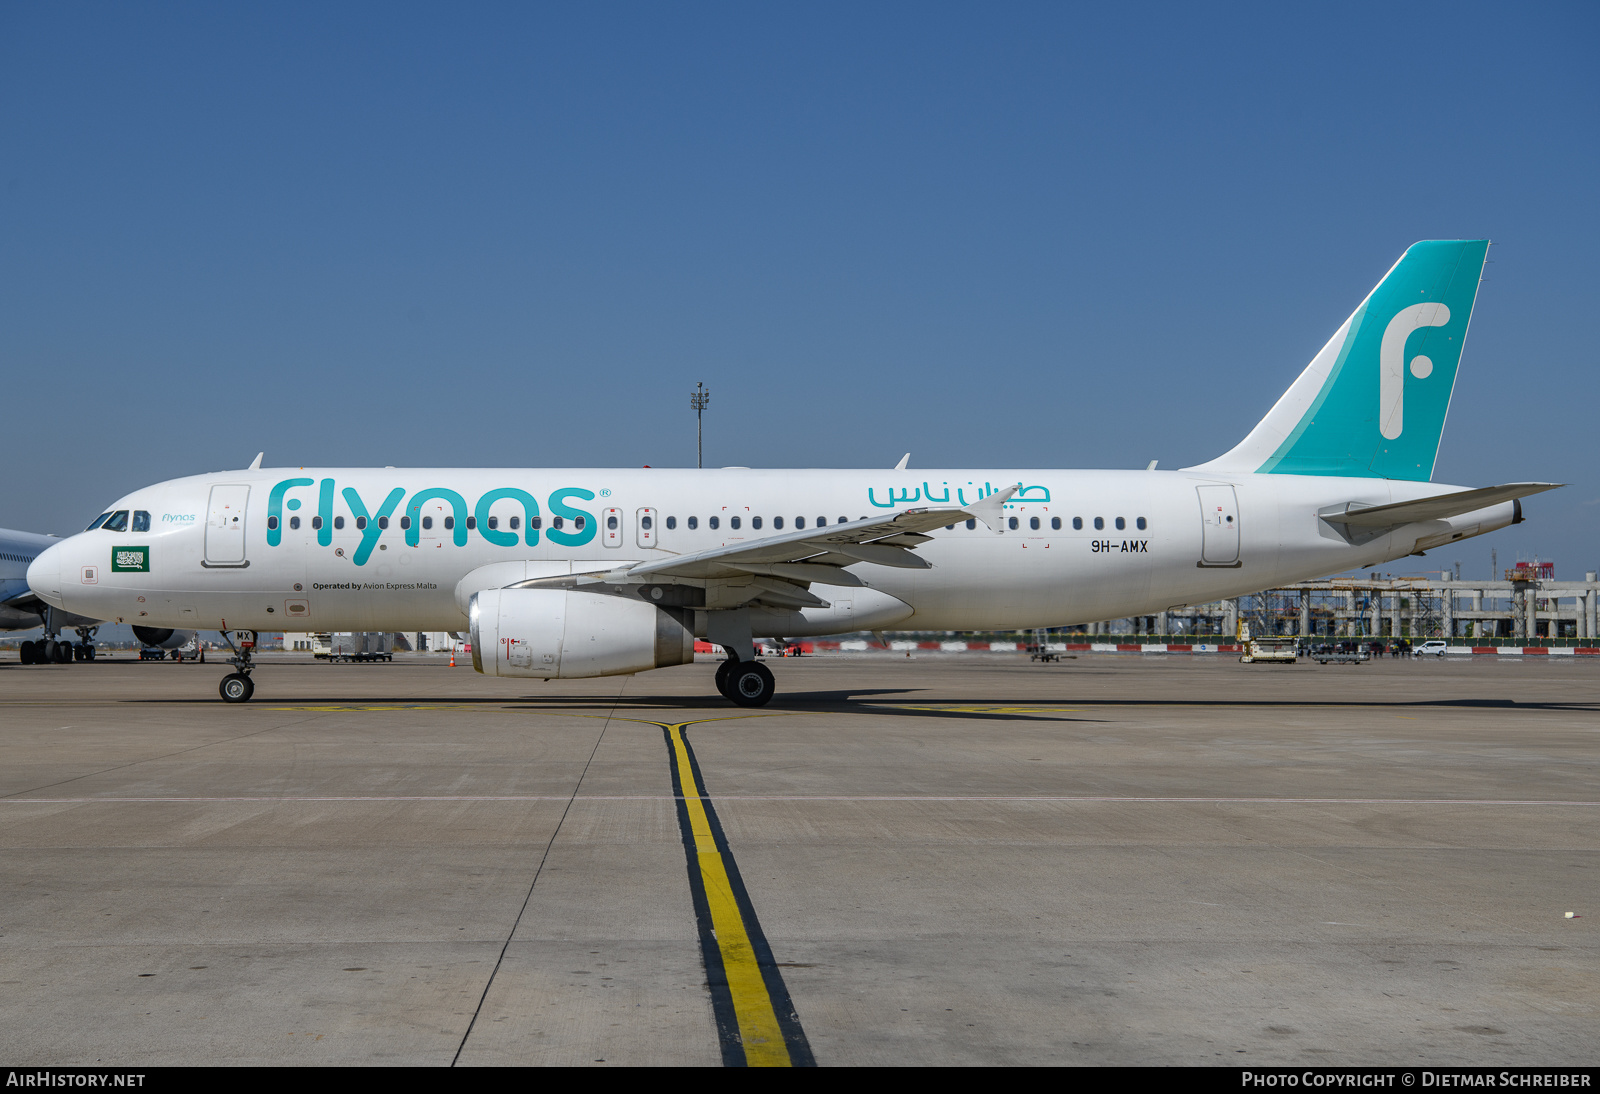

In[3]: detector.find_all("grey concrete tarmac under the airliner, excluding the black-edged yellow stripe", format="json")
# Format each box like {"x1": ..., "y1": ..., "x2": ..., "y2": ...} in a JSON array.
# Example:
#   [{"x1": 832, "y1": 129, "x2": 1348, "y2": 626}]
[{"x1": 0, "y1": 654, "x2": 1600, "y2": 1067}]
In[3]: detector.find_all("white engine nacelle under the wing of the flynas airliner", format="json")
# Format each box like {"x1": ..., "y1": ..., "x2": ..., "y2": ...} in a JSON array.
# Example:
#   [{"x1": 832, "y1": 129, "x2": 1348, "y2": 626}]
[{"x1": 467, "y1": 589, "x2": 694, "y2": 680}]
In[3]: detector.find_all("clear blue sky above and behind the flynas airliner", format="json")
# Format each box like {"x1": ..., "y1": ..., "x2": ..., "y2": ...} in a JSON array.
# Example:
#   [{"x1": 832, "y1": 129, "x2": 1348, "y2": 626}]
[{"x1": 0, "y1": 3, "x2": 1600, "y2": 577}]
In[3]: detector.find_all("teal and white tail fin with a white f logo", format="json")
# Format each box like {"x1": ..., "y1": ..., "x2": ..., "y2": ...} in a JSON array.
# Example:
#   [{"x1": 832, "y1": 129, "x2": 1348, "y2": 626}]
[{"x1": 1195, "y1": 240, "x2": 1490, "y2": 481}]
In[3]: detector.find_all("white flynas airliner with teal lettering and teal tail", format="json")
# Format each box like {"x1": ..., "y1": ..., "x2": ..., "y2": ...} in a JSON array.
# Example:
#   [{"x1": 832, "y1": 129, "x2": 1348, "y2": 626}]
[{"x1": 27, "y1": 240, "x2": 1554, "y2": 705}]
